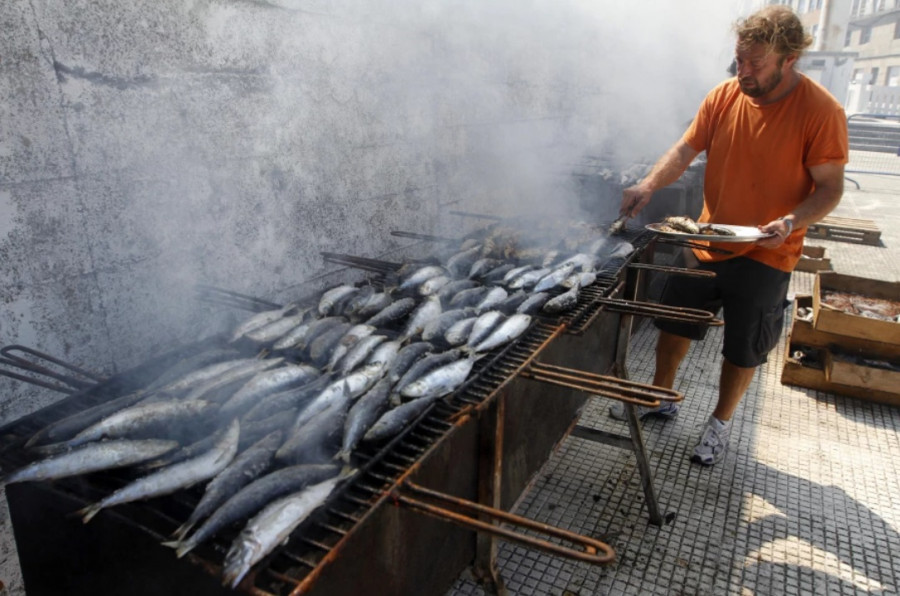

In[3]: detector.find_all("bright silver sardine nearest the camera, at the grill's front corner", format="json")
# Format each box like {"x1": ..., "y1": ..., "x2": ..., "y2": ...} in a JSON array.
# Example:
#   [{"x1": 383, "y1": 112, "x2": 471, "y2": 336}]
[{"x1": 222, "y1": 476, "x2": 342, "y2": 588}]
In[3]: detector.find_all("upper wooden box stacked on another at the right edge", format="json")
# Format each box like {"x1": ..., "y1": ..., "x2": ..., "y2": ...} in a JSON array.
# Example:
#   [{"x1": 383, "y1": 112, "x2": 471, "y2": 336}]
[{"x1": 813, "y1": 271, "x2": 900, "y2": 345}]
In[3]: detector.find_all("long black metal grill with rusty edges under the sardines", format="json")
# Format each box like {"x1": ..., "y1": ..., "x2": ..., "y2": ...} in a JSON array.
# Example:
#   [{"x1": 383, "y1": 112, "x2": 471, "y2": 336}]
[{"x1": 0, "y1": 221, "x2": 715, "y2": 594}]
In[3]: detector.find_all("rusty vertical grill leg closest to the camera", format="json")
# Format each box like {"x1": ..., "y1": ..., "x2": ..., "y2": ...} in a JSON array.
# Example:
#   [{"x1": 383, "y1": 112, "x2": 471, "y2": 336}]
[{"x1": 472, "y1": 390, "x2": 507, "y2": 596}]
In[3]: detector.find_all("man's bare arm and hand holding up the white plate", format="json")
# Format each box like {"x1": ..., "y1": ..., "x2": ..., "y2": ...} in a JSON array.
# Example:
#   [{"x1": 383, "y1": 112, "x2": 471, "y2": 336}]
[{"x1": 757, "y1": 163, "x2": 844, "y2": 248}]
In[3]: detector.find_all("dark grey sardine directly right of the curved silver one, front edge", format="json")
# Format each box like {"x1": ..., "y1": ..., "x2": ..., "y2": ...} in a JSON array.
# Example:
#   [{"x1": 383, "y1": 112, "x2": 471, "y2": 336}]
[{"x1": 173, "y1": 430, "x2": 283, "y2": 540}]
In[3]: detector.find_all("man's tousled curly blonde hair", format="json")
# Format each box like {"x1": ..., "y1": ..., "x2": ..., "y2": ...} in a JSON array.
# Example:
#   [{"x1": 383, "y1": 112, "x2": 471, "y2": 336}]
[{"x1": 734, "y1": 5, "x2": 813, "y2": 57}]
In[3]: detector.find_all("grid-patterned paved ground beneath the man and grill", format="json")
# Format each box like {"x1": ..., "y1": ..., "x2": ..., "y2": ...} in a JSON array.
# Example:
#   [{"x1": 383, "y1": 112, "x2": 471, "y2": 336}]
[{"x1": 449, "y1": 175, "x2": 900, "y2": 596}]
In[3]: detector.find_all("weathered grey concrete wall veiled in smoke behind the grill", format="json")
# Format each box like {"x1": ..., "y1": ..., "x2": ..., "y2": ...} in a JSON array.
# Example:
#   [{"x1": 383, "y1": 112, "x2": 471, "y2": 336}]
[{"x1": 0, "y1": 0, "x2": 735, "y2": 421}]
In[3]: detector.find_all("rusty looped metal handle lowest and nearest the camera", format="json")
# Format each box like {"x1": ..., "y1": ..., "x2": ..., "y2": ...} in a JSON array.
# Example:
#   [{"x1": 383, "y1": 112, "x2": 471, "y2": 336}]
[{"x1": 393, "y1": 480, "x2": 616, "y2": 565}]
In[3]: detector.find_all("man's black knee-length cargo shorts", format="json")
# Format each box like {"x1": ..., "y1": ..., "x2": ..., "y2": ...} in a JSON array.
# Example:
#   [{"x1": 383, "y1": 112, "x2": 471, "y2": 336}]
[{"x1": 656, "y1": 257, "x2": 791, "y2": 368}]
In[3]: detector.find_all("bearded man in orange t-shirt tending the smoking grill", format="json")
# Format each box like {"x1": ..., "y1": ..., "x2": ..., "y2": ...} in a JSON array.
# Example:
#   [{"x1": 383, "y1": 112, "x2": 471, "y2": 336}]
[{"x1": 610, "y1": 6, "x2": 848, "y2": 465}]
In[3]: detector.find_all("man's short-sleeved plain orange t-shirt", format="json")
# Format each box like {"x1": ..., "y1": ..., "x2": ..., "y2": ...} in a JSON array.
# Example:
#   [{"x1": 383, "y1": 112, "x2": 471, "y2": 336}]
[{"x1": 682, "y1": 75, "x2": 848, "y2": 272}]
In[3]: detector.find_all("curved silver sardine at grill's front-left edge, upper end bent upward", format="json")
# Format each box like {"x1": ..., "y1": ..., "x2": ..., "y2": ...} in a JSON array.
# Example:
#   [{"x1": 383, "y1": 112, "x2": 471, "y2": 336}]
[{"x1": 78, "y1": 420, "x2": 241, "y2": 523}]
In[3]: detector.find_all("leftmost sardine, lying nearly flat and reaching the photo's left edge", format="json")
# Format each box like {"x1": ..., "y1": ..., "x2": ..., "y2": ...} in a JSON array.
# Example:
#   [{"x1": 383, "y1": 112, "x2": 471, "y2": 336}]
[{"x1": 0, "y1": 439, "x2": 178, "y2": 485}]
